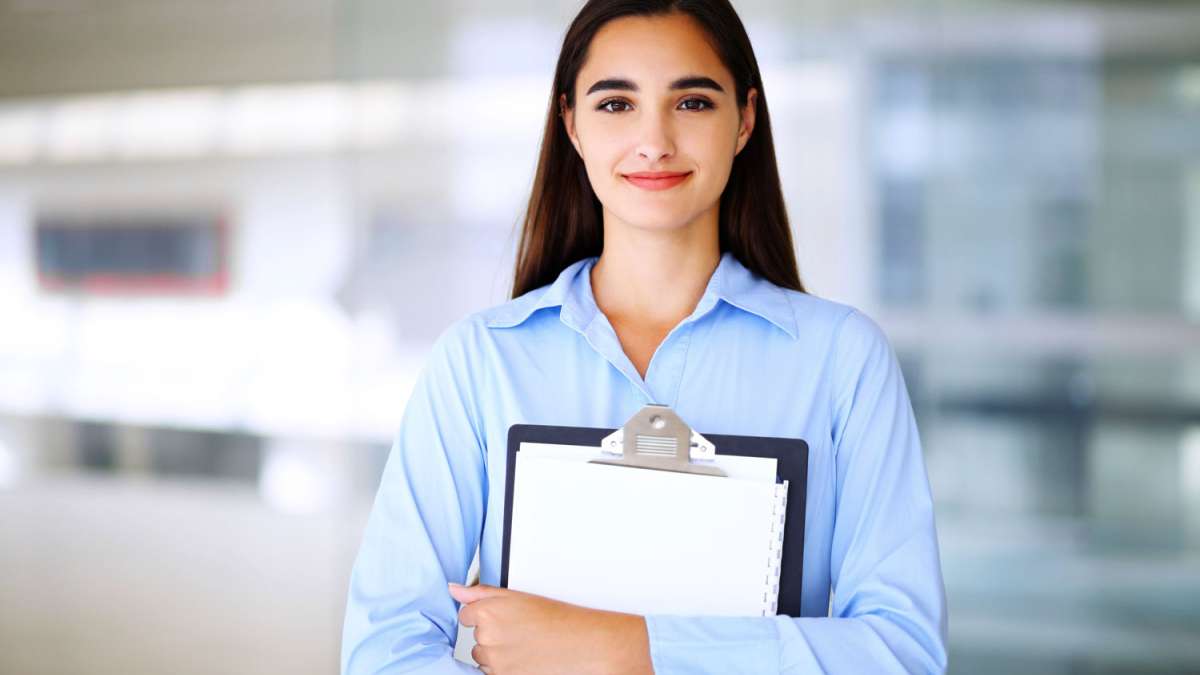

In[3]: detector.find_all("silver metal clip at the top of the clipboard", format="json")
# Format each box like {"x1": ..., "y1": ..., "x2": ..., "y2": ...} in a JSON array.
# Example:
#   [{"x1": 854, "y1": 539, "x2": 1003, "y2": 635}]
[{"x1": 590, "y1": 404, "x2": 726, "y2": 477}]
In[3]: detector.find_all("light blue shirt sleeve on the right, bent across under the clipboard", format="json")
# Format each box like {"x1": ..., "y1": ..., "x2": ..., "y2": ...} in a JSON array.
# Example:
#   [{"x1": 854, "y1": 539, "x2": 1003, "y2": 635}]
[{"x1": 646, "y1": 311, "x2": 947, "y2": 675}]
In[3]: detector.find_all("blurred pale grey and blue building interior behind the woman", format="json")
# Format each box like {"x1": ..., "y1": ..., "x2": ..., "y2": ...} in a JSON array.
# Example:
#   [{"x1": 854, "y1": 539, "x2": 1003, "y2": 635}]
[{"x1": 0, "y1": 0, "x2": 1200, "y2": 675}]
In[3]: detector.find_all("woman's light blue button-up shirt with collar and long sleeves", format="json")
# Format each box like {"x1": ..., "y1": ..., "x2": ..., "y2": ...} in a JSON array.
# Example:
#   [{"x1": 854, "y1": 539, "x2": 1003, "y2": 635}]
[{"x1": 342, "y1": 253, "x2": 947, "y2": 675}]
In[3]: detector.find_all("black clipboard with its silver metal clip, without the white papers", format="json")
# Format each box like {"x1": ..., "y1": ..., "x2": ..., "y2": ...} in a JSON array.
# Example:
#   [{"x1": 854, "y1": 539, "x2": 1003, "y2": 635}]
[{"x1": 500, "y1": 404, "x2": 809, "y2": 616}]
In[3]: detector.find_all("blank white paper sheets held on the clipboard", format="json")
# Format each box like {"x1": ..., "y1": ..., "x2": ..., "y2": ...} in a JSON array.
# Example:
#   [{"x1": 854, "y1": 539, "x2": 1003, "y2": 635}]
[{"x1": 509, "y1": 443, "x2": 775, "y2": 616}]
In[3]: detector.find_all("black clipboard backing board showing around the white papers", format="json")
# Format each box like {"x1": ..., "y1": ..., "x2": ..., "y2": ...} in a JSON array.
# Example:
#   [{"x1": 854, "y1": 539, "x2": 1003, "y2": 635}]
[{"x1": 500, "y1": 424, "x2": 809, "y2": 616}]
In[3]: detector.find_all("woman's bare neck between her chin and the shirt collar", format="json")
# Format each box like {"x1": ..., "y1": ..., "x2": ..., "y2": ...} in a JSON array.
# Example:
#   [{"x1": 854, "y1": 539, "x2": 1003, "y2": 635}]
[{"x1": 592, "y1": 208, "x2": 721, "y2": 328}]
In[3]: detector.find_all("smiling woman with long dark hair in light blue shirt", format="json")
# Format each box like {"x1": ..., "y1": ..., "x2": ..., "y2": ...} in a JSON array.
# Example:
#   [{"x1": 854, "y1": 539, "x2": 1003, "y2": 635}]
[{"x1": 342, "y1": 0, "x2": 946, "y2": 675}]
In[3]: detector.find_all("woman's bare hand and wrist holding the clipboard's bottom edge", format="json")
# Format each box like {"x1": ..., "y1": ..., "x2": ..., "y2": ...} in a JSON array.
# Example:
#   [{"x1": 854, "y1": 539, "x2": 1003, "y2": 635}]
[{"x1": 450, "y1": 584, "x2": 654, "y2": 675}]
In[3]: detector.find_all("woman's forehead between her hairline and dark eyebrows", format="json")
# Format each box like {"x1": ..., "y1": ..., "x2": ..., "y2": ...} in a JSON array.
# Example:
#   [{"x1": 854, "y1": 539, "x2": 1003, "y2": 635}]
[{"x1": 576, "y1": 13, "x2": 733, "y2": 91}]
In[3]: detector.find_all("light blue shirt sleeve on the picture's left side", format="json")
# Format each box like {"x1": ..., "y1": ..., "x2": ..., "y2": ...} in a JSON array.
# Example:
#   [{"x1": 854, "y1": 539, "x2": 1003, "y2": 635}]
[{"x1": 341, "y1": 323, "x2": 487, "y2": 675}]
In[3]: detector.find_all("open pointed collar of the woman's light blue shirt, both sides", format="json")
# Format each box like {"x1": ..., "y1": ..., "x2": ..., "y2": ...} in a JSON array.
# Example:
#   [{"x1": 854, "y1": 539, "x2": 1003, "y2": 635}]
[{"x1": 486, "y1": 251, "x2": 798, "y2": 340}]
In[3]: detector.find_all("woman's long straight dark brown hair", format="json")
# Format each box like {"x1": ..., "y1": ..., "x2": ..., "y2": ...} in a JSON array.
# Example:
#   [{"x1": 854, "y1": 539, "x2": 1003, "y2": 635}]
[{"x1": 512, "y1": 0, "x2": 804, "y2": 298}]
